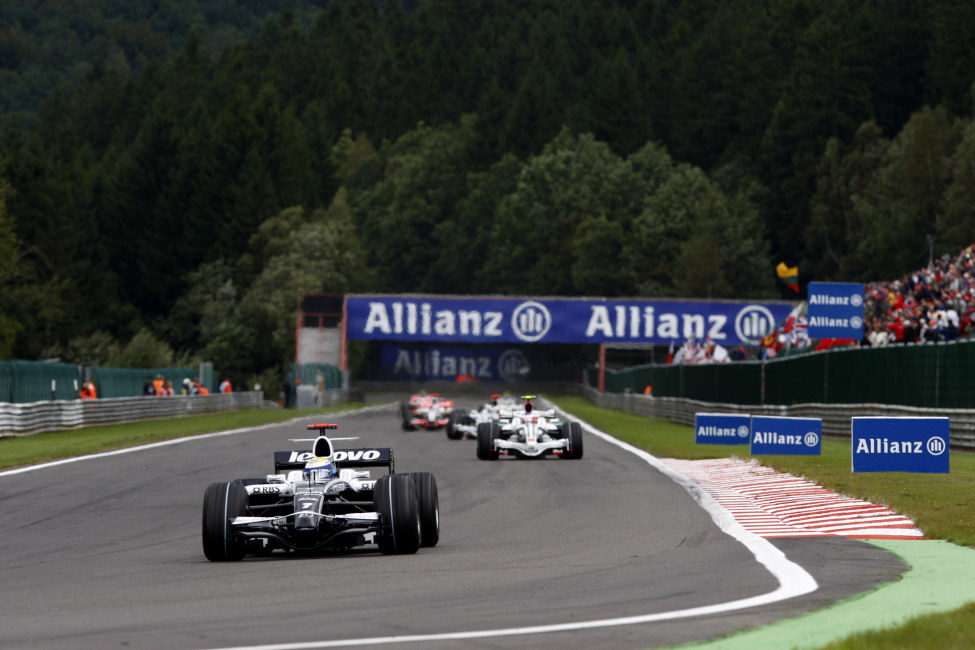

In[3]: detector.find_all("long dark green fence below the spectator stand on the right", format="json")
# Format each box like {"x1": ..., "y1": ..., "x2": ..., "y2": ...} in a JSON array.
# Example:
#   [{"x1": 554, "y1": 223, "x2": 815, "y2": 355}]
[{"x1": 588, "y1": 341, "x2": 975, "y2": 409}]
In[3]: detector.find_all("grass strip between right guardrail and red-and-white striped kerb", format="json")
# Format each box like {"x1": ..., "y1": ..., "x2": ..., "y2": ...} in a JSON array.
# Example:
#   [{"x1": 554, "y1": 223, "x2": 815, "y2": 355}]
[{"x1": 551, "y1": 396, "x2": 975, "y2": 547}]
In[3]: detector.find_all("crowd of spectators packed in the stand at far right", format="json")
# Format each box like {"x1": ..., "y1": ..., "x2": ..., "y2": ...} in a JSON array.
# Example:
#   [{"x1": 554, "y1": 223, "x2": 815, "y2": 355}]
[{"x1": 861, "y1": 244, "x2": 975, "y2": 346}]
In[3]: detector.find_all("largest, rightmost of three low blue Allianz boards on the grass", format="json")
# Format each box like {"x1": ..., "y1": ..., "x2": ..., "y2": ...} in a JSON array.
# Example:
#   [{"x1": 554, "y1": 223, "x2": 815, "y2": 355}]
[{"x1": 852, "y1": 417, "x2": 949, "y2": 474}]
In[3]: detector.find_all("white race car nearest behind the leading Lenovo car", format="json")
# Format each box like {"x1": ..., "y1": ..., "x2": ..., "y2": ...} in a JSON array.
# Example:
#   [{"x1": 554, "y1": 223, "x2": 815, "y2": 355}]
[{"x1": 477, "y1": 395, "x2": 582, "y2": 460}]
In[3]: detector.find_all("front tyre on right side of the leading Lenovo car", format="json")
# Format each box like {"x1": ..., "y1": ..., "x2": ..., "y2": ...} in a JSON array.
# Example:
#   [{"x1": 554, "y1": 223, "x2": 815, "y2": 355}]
[{"x1": 373, "y1": 474, "x2": 420, "y2": 555}]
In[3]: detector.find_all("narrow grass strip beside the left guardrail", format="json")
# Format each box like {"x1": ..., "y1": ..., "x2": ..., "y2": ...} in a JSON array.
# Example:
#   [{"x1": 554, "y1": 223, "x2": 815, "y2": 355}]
[{"x1": 0, "y1": 402, "x2": 365, "y2": 469}]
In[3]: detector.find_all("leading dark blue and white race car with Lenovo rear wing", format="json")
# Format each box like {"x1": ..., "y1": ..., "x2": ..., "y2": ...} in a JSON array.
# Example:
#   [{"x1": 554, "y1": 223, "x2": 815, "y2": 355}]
[{"x1": 203, "y1": 424, "x2": 440, "y2": 561}]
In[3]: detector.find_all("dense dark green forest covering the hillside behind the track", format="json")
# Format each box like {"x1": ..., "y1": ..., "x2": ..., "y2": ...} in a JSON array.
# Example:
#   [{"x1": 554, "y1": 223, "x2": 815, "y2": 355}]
[{"x1": 0, "y1": 0, "x2": 975, "y2": 390}]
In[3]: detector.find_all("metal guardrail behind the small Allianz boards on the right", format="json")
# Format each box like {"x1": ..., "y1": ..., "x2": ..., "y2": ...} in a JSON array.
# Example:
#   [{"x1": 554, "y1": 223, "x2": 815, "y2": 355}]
[{"x1": 580, "y1": 386, "x2": 975, "y2": 449}]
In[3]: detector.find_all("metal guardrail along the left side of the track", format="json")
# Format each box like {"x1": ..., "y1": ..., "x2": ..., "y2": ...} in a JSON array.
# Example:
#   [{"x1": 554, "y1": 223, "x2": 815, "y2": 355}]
[{"x1": 0, "y1": 391, "x2": 270, "y2": 437}]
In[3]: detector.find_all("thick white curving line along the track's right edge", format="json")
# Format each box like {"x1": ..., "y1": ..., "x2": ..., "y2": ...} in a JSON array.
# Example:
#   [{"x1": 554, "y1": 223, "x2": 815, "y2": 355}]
[{"x1": 202, "y1": 400, "x2": 819, "y2": 650}]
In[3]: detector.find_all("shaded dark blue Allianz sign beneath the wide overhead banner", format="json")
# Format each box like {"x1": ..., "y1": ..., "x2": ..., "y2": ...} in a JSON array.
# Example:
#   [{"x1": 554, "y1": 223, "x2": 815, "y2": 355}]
[{"x1": 380, "y1": 343, "x2": 531, "y2": 382}]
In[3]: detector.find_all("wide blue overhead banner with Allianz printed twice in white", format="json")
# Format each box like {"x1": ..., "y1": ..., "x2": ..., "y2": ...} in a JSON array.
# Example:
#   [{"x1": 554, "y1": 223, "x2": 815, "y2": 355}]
[{"x1": 346, "y1": 295, "x2": 791, "y2": 346}]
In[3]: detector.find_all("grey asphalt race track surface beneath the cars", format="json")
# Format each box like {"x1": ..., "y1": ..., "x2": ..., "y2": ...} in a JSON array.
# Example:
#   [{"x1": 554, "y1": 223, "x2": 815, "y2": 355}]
[{"x1": 0, "y1": 400, "x2": 904, "y2": 648}]
